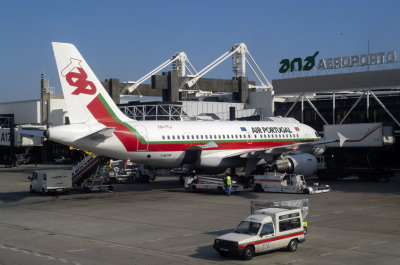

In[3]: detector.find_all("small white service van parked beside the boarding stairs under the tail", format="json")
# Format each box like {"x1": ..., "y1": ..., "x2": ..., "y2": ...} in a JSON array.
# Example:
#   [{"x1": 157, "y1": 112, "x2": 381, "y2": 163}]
[{"x1": 29, "y1": 169, "x2": 72, "y2": 194}]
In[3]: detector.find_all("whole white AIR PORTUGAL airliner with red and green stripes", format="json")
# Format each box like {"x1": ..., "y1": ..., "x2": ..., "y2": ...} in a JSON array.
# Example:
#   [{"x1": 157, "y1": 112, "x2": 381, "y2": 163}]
[{"x1": 48, "y1": 42, "x2": 345, "y2": 175}]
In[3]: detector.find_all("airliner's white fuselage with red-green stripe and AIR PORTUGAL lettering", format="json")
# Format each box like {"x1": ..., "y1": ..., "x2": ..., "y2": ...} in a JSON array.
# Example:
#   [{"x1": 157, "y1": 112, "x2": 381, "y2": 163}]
[{"x1": 49, "y1": 121, "x2": 319, "y2": 167}]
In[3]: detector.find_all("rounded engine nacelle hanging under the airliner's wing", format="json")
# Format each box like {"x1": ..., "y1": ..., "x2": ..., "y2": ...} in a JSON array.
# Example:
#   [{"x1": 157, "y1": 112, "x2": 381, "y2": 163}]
[{"x1": 273, "y1": 154, "x2": 317, "y2": 177}]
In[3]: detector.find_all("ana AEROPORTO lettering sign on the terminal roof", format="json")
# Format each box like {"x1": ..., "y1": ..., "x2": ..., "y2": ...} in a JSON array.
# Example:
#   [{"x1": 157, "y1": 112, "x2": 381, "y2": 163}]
[{"x1": 279, "y1": 51, "x2": 396, "y2": 73}]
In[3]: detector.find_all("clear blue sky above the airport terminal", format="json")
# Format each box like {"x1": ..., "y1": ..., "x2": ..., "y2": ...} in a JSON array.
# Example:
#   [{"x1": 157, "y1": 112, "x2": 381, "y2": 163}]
[{"x1": 0, "y1": 0, "x2": 400, "y2": 102}]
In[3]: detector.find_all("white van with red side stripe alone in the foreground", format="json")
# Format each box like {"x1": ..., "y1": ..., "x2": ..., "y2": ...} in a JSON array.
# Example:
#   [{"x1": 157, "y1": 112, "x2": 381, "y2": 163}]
[{"x1": 213, "y1": 208, "x2": 305, "y2": 260}]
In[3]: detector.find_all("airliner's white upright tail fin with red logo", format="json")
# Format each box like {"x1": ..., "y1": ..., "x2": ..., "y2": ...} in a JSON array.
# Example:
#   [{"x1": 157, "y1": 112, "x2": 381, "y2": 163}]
[{"x1": 52, "y1": 42, "x2": 129, "y2": 126}]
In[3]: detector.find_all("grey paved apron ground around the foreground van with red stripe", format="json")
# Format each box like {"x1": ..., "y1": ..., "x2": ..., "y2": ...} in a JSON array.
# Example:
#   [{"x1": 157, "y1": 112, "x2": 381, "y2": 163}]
[{"x1": 0, "y1": 165, "x2": 400, "y2": 265}]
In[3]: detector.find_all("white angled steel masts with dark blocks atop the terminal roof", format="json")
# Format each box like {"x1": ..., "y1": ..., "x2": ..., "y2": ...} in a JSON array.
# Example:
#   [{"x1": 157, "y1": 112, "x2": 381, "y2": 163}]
[{"x1": 112, "y1": 43, "x2": 272, "y2": 103}]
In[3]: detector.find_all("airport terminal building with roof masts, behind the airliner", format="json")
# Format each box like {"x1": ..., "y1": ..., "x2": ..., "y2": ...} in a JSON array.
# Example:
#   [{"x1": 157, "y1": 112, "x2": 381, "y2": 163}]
[{"x1": 0, "y1": 44, "x2": 400, "y2": 169}]
